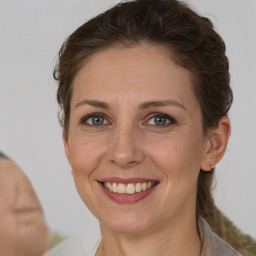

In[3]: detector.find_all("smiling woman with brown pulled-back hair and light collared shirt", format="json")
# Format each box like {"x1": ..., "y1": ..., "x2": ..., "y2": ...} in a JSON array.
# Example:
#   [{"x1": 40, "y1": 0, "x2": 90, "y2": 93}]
[{"x1": 47, "y1": 0, "x2": 239, "y2": 256}]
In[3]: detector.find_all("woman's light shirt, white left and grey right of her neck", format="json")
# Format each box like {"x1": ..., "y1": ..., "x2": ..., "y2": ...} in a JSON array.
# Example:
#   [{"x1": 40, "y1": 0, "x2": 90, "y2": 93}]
[{"x1": 44, "y1": 218, "x2": 241, "y2": 256}]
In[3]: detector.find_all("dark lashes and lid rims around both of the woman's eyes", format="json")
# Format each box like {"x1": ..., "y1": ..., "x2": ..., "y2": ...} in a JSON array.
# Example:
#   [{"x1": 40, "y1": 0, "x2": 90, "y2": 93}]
[{"x1": 79, "y1": 113, "x2": 177, "y2": 128}]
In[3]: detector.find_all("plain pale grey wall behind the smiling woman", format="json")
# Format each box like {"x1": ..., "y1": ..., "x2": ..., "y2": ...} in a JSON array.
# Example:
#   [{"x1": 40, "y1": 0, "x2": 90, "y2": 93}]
[{"x1": 0, "y1": 0, "x2": 256, "y2": 238}]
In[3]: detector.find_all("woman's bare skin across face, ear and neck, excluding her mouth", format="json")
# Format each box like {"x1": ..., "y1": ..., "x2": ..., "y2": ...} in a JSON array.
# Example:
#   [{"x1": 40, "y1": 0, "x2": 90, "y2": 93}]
[{"x1": 63, "y1": 45, "x2": 230, "y2": 256}]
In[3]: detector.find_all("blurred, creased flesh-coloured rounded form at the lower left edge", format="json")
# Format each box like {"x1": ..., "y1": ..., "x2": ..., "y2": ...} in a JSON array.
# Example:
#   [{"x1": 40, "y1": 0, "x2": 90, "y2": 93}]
[{"x1": 0, "y1": 158, "x2": 50, "y2": 256}]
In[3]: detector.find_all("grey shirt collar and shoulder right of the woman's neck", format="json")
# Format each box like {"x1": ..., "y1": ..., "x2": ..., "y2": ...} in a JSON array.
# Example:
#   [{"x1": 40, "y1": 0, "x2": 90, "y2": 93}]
[{"x1": 199, "y1": 218, "x2": 241, "y2": 256}]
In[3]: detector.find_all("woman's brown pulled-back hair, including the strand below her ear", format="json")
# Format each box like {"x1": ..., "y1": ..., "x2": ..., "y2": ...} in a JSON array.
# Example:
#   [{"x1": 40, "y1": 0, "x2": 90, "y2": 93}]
[{"x1": 54, "y1": 0, "x2": 233, "y2": 217}]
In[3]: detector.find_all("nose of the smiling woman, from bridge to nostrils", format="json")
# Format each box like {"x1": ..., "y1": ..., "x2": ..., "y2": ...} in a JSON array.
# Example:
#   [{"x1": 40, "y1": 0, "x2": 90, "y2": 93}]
[{"x1": 108, "y1": 127, "x2": 144, "y2": 168}]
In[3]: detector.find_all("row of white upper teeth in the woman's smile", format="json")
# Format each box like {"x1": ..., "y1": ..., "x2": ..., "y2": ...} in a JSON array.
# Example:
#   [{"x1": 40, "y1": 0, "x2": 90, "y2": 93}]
[{"x1": 104, "y1": 182, "x2": 155, "y2": 195}]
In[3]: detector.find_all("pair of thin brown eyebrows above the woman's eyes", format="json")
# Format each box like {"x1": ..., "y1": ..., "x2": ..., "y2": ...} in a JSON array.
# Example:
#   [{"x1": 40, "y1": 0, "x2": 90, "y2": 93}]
[{"x1": 74, "y1": 100, "x2": 187, "y2": 111}]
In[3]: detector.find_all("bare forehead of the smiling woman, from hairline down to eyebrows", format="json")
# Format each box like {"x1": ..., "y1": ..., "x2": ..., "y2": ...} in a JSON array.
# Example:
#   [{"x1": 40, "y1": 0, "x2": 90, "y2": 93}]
[{"x1": 71, "y1": 45, "x2": 198, "y2": 108}]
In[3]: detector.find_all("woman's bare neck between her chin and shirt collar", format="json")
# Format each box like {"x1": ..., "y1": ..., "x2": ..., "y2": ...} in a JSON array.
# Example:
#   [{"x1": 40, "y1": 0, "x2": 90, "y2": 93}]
[{"x1": 97, "y1": 214, "x2": 201, "y2": 256}]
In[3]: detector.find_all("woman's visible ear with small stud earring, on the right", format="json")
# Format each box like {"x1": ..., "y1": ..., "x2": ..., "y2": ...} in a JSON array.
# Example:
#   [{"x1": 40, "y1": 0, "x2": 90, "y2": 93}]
[{"x1": 200, "y1": 116, "x2": 231, "y2": 171}]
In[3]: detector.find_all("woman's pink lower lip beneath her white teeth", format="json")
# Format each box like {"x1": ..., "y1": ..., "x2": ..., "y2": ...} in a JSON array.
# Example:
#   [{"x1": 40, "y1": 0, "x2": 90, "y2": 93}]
[{"x1": 99, "y1": 182, "x2": 158, "y2": 204}]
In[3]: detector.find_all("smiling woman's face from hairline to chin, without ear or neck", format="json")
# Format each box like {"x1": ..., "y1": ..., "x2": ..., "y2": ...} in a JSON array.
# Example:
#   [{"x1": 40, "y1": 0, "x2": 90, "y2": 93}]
[{"x1": 64, "y1": 45, "x2": 212, "y2": 233}]
